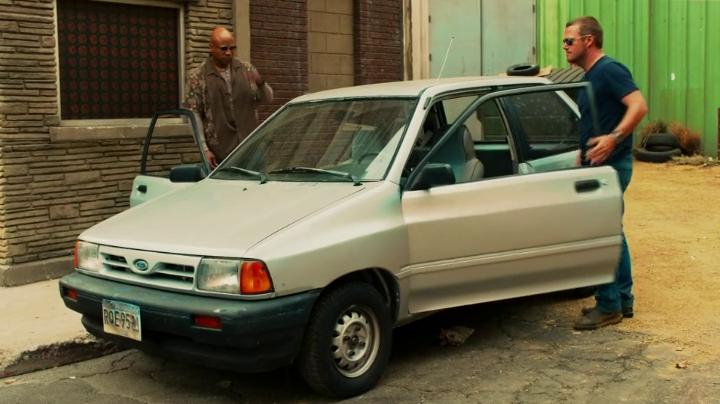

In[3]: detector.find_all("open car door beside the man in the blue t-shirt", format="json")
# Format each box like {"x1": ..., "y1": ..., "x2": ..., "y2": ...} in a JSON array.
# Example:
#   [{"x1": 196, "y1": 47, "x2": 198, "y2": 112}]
[{"x1": 402, "y1": 83, "x2": 622, "y2": 313}]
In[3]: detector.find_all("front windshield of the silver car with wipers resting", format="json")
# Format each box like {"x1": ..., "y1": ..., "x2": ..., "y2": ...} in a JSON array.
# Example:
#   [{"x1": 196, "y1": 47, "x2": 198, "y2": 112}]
[{"x1": 211, "y1": 98, "x2": 417, "y2": 184}]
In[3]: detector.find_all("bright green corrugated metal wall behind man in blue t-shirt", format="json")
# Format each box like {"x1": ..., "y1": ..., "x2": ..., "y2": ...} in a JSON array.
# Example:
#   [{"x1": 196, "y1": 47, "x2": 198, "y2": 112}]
[{"x1": 537, "y1": 0, "x2": 720, "y2": 156}]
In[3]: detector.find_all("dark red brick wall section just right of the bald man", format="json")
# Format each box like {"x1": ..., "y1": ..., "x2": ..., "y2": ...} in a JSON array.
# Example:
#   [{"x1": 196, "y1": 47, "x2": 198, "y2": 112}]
[{"x1": 250, "y1": 0, "x2": 308, "y2": 119}]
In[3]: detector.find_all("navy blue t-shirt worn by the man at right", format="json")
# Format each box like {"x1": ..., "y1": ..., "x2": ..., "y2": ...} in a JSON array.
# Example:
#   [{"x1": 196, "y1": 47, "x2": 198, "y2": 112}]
[{"x1": 578, "y1": 56, "x2": 638, "y2": 165}]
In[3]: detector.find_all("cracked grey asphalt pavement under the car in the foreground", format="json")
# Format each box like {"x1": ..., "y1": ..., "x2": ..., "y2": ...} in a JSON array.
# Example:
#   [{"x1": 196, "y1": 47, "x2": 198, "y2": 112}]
[{"x1": 0, "y1": 295, "x2": 720, "y2": 404}]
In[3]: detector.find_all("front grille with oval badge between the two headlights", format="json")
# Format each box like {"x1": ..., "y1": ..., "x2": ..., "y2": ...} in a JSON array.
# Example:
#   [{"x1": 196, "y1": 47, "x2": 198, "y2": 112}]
[{"x1": 100, "y1": 246, "x2": 200, "y2": 290}]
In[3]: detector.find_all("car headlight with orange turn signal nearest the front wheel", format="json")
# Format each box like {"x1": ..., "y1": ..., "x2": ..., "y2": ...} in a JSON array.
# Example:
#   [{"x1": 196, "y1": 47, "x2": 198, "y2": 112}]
[{"x1": 196, "y1": 258, "x2": 273, "y2": 295}]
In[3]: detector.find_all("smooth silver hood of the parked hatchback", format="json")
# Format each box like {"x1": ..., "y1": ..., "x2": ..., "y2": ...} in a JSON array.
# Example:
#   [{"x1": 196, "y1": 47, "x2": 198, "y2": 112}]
[{"x1": 80, "y1": 179, "x2": 366, "y2": 257}]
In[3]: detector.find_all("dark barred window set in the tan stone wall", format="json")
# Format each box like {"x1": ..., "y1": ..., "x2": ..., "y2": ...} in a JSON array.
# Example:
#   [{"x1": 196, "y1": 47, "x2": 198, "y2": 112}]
[{"x1": 57, "y1": 0, "x2": 181, "y2": 120}]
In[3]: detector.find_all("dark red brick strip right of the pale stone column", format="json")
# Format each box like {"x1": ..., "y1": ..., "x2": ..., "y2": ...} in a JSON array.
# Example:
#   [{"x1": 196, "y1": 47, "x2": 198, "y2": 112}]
[{"x1": 354, "y1": 0, "x2": 403, "y2": 84}]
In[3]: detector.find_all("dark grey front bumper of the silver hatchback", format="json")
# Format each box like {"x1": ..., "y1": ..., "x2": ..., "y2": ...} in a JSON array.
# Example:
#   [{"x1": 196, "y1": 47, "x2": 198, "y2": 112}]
[{"x1": 60, "y1": 273, "x2": 320, "y2": 372}]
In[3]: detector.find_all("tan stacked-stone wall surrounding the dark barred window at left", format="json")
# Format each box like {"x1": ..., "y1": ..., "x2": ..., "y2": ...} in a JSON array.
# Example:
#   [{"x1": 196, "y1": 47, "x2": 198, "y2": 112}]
[{"x1": 0, "y1": 0, "x2": 232, "y2": 286}]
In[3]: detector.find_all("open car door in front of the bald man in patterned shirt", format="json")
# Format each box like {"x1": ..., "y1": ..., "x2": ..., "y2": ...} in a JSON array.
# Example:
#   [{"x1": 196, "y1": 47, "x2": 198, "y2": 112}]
[{"x1": 130, "y1": 109, "x2": 210, "y2": 207}]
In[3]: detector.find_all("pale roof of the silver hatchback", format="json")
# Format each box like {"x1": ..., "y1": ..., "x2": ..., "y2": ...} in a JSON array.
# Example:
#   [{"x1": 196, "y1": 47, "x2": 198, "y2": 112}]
[{"x1": 291, "y1": 76, "x2": 551, "y2": 103}]
